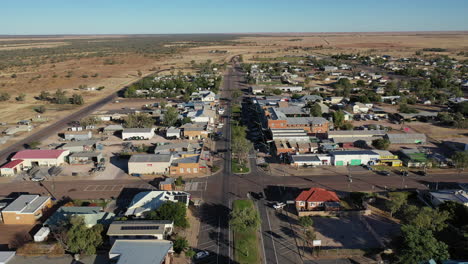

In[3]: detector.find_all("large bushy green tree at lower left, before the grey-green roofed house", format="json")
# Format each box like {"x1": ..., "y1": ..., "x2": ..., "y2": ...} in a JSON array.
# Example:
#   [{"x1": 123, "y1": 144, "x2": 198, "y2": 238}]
[{"x1": 52, "y1": 216, "x2": 104, "y2": 255}]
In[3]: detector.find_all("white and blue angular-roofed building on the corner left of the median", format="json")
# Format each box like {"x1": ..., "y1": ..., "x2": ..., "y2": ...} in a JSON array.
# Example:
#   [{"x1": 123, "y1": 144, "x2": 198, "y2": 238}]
[{"x1": 125, "y1": 191, "x2": 190, "y2": 217}]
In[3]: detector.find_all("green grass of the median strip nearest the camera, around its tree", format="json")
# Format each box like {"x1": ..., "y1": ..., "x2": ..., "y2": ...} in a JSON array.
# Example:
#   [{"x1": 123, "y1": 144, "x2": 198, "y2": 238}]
[{"x1": 232, "y1": 200, "x2": 260, "y2": 264}]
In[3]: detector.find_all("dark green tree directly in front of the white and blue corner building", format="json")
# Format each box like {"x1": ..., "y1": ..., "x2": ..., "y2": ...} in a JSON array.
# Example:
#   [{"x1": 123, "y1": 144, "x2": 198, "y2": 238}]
[{"x1": 145, "y1": 201, "x2": 189, "y2": 228}]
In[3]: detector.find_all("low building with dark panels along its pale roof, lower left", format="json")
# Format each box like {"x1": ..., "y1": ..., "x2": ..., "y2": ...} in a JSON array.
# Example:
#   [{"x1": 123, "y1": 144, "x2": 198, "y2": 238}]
[{"x1": 107, "y1": 220, "x2": 174, "y2": 245}]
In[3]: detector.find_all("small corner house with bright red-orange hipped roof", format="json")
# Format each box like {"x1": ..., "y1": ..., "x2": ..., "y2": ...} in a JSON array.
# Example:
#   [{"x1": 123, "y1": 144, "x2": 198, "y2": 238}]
[{"x1": 294, "y1": 188, "x2": 341, "y2": 212}]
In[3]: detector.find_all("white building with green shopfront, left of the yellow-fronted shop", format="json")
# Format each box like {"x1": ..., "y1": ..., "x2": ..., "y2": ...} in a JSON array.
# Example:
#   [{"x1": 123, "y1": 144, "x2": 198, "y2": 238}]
[{"x1": 330, "y1": 150, "x2": 380, "y2": 166}]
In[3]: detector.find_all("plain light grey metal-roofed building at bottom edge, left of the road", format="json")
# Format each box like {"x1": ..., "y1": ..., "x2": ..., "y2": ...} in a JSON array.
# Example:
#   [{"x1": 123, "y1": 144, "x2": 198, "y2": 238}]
[{"x1": 109, "y1": 240, "x2": 174, "y2": 264}]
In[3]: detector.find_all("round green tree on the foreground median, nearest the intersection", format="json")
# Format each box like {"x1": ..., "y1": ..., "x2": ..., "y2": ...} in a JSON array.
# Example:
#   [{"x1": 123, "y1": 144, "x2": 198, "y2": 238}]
[{"x1": 229, "y1": 202, "x2": 260, "y2": 232}]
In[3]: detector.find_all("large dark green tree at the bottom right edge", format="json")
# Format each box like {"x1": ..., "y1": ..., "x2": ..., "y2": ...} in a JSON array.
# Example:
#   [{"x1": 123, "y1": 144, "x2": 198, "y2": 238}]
[{"x1": 397, "y1": 225, "x2": 449, "y2": 264}]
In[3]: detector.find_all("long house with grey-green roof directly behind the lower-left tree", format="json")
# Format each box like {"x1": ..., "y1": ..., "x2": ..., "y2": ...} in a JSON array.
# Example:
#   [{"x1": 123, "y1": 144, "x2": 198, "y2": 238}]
[{"x1": 43, "y1": 206, "x2": 115, "y2": 228}]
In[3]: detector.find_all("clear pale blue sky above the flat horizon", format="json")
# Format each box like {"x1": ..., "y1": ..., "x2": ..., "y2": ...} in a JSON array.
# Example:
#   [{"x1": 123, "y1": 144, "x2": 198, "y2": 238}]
[{"x1": 0, "y1": 0, "x2": 468, "y2": 35}]
